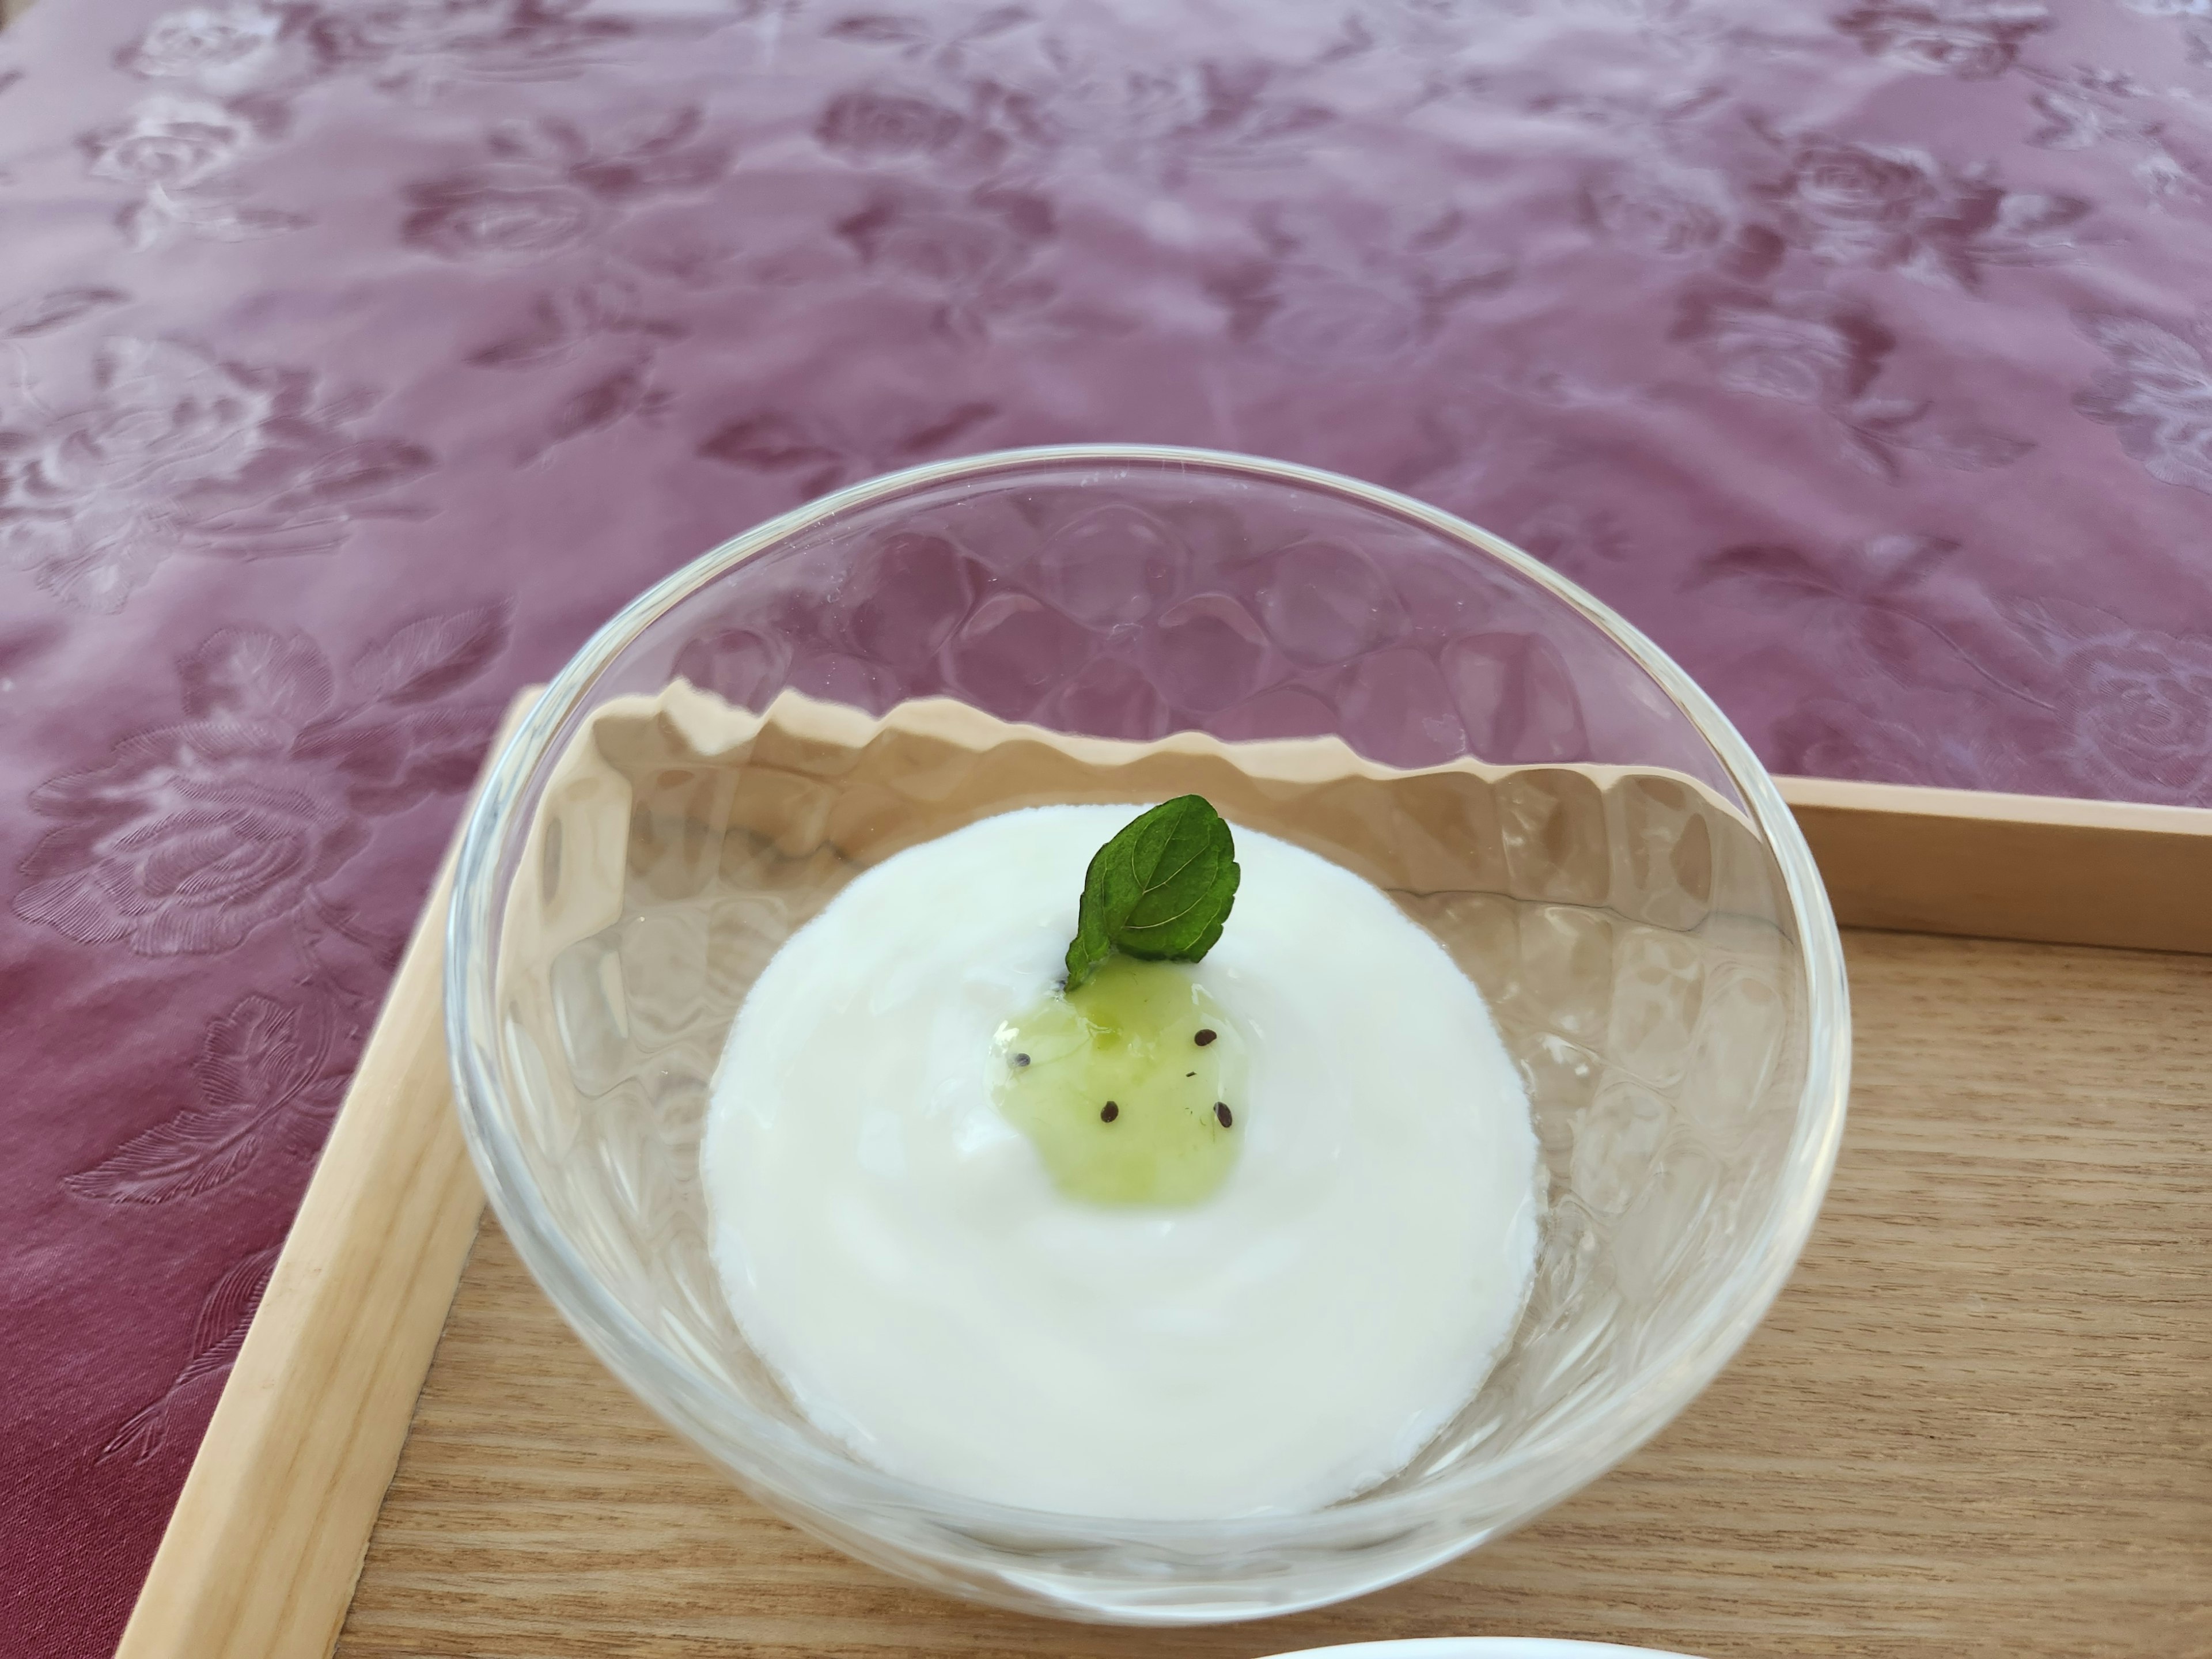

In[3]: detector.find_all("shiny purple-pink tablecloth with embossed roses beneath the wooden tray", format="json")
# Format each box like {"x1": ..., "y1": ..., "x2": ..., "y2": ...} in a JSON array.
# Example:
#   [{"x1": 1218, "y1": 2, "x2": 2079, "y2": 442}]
[{"x1": 0, "y1": 0, "x2": 2212, "y2": 1659}]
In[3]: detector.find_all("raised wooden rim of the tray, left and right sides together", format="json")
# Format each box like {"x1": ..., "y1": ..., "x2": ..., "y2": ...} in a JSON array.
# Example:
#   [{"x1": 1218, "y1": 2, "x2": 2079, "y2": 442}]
[{"x1": 118, "y1": 756, "x2": 2212, "y2": 1659}]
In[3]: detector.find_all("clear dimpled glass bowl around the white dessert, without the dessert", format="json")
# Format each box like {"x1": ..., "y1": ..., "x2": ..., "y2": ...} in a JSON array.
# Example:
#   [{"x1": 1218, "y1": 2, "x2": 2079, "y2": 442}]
[{"x1": 447, "y1": 447, "x2": 1849, "y2": 1624}]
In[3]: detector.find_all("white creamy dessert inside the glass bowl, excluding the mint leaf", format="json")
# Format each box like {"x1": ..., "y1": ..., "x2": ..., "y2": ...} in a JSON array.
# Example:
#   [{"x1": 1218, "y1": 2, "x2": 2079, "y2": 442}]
[{"x1": 703, "y1": 805, "x2": 1537, "y2": 1520}]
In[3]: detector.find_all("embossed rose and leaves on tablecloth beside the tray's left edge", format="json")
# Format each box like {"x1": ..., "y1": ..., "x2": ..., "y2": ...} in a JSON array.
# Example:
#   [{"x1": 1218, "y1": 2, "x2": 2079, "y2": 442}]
[{"x1": 13, "y1": 606, "x2": 506, "y2": 1424}]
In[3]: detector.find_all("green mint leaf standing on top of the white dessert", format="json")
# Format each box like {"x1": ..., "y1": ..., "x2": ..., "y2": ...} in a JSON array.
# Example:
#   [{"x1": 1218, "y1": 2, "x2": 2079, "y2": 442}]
[{"x1": 1069, "y1": 794, "x2": 1241, "y2": 991}]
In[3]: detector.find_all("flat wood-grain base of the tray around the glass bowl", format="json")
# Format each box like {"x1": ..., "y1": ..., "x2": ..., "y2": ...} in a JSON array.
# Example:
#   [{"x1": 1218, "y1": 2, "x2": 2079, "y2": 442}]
[{"x1": 339, "y1": 933, "x2": 2212, "y2": 1659}]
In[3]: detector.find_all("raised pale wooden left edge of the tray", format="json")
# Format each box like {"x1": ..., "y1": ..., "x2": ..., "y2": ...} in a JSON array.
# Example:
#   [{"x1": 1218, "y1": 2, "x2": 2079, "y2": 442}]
[{"x1": 118, "y1": 692, "x2": 535, "y2": 1659}]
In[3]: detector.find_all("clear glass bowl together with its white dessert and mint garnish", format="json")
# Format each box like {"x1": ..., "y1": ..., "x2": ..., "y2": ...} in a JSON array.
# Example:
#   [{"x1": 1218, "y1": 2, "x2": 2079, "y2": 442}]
[{"x1": 449, "y1": 447, "x2": 1847, "y2": 1624}]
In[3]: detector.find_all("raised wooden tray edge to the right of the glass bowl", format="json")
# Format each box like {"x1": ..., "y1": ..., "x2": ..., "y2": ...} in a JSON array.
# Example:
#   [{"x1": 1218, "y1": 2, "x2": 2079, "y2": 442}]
[{"x1": 1777, "y1": 779, "x2": 2212, "y2": 951}]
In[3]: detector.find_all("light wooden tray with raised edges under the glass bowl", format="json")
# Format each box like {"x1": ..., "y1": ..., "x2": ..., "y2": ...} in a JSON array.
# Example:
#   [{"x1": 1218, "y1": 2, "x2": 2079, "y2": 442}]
[{"x1": 119, "y1": 706, "x2": 2212, "y2": 1659}]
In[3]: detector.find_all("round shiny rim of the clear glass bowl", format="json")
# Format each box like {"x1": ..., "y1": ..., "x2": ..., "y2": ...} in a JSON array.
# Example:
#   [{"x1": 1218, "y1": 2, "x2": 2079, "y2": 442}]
[{"x1": 447, "y1": 445, "x2": 1849, "y2": 1575}]
